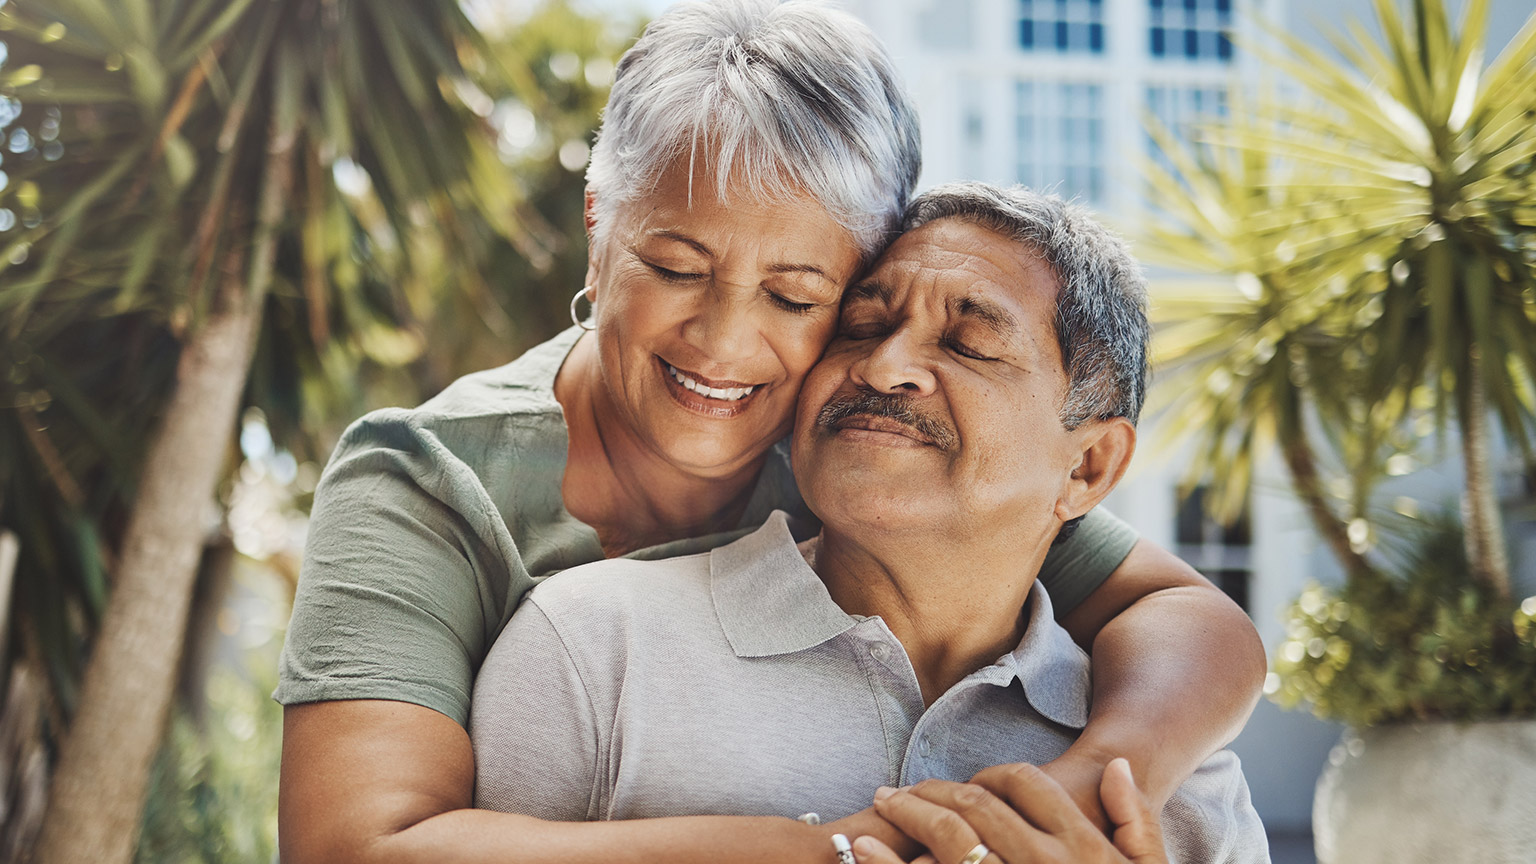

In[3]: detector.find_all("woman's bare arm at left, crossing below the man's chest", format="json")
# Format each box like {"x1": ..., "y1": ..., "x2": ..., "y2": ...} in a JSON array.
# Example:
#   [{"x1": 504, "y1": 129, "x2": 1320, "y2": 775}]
[{"x1": 278, "y1": 700, "x2": 915, "y2": 864}]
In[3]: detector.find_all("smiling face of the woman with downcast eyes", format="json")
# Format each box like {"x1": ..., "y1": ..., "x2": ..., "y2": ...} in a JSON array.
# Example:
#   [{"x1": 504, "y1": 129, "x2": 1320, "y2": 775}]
[{"x1": 588, "y1": 158, "x2": 860, "y2": 477}]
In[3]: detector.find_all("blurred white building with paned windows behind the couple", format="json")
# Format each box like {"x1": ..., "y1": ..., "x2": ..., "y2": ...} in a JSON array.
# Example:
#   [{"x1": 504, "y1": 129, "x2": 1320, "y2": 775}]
[{"x1": 842, "y1": 0, "x2": 1536, "y2": 861}]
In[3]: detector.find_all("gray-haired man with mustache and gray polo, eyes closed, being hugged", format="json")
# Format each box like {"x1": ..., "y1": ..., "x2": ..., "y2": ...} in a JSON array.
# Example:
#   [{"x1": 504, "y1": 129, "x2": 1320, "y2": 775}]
[{"x1": 470, "y1": 184, "x2": 1267, "y2": 864}]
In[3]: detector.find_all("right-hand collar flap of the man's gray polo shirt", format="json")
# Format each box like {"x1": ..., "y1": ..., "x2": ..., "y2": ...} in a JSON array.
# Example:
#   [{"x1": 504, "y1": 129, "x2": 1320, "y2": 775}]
[{"x1": 994, "y1": 580, "x2": 1092, "y2": 729}]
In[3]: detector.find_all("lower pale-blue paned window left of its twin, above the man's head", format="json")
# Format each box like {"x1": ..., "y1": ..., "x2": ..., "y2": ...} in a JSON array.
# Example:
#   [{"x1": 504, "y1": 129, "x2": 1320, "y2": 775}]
[{"x1": 1014, "y1": 81, "x2": 1104, "y2": 204}]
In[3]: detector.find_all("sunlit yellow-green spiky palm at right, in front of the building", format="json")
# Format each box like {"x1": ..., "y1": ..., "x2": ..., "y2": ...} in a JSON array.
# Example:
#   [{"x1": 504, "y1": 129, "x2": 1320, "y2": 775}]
[{"x1": 1152, "y1": 0, "x2": 1536, "y2": 598}]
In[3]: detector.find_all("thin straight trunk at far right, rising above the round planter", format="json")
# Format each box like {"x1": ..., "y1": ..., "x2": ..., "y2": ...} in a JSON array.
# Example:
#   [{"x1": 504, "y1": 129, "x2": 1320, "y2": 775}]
[{"x1": 1461, "y1": 347, "x2": 1510, "y2": 600}]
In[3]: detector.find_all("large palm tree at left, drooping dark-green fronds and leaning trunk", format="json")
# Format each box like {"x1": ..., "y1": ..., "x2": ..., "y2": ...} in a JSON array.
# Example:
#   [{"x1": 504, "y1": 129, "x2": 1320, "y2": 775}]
[{"x1": 0, "y1": 0, "x2": 559, "y2": 864}]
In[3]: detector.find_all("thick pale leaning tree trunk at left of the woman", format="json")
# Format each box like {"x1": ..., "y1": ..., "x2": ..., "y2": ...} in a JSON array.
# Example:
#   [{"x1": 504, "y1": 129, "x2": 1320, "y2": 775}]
[{"x1": 37, "y1": 244, "x2": 263, "y2": 864}]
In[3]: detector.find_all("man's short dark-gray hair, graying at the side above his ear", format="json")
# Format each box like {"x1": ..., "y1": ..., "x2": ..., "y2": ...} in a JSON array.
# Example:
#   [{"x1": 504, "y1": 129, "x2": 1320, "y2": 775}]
[{"x1": 903, "y1": 183, "x2": 1152, "y2": 429}]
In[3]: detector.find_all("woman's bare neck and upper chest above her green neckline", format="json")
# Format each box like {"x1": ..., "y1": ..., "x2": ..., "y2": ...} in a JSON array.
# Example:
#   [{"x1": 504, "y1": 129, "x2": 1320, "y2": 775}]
[{"x1": 554, "y1": 338, "x2": 766, "y2": 558}]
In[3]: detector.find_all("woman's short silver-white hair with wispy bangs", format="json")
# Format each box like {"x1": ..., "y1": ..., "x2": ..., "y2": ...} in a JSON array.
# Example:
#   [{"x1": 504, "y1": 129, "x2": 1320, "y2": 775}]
[{"x1": 587, "y1": 0, "x2": 922, "y2": 260}]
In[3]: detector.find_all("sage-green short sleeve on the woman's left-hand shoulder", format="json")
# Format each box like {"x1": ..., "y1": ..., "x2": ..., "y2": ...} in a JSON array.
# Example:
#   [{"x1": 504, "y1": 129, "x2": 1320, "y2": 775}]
[{"x1": 273, "y1": 409, "x2": 533, "y2": 724}]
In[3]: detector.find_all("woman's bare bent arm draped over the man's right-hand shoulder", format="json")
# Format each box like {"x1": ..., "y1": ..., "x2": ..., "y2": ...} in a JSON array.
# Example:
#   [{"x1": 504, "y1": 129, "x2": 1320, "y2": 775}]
[{"x1": 1043, "y1": 540, "x2": 1266, "y2": 827}]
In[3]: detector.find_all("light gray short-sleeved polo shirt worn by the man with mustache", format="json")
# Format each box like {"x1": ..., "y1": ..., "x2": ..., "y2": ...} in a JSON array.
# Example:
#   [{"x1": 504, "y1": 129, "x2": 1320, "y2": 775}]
[{"x1": 470, "y1": 513, "x2": 1269, "y2": 862}]
